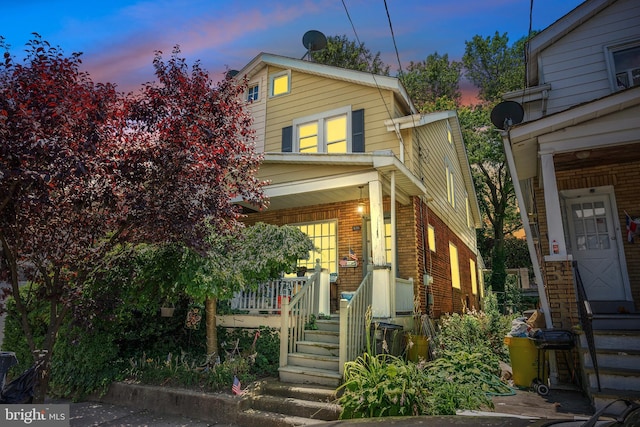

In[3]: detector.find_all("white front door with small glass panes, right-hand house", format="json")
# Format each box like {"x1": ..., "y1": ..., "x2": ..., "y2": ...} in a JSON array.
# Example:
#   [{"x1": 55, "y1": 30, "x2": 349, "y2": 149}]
[{"x1": 565, "y1": 194, "x2": 629, "y2": 301}]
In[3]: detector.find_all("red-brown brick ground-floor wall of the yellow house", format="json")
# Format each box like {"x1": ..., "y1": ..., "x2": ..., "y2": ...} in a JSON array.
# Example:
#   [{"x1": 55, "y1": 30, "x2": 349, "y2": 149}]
[{"x1": 245, "y1": 198, "x2": 480, "y2": 317}]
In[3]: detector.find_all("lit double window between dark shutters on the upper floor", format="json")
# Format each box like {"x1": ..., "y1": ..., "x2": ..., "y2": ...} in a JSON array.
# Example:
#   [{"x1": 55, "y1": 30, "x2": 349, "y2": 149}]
[{"x1": 293, "y1": 107, "x2": 351, "y2": 153}]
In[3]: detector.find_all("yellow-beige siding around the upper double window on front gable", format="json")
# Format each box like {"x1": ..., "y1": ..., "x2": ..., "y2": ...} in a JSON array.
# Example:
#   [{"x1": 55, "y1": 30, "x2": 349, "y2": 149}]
[{"x1": 265, "y1": 67, "x2": 399, "y2": 155}]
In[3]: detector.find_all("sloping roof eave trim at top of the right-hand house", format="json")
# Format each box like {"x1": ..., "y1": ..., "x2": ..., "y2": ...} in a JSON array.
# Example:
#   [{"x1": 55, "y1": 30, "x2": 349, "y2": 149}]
[{"x1": 527, "y1": 0, "x2": 617, "y2": 86}]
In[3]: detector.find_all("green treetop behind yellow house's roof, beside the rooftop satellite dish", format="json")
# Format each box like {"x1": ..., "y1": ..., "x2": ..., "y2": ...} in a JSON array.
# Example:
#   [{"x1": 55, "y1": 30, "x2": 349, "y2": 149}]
[{"x1": 311, "y1": 35, "x2": 389, "y2": 76}]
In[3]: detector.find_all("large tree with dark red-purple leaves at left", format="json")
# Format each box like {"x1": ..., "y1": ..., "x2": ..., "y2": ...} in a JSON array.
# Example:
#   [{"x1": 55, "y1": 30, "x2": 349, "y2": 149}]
[{"x1": 0, "y1": 34, "x2": 265, "y2": 402}]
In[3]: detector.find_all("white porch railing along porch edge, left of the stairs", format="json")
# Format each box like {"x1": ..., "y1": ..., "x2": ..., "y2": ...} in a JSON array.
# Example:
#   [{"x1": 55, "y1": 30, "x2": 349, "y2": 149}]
[{"x1": 231, "y1": 273, "x2": 319, "y2": 314}]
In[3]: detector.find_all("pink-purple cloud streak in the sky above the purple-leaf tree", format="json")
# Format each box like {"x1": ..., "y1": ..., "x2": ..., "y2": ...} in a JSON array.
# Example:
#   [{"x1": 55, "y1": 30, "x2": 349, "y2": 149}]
[{"x1": 83, "y1": 1, "x2": 328, "y2": 91}]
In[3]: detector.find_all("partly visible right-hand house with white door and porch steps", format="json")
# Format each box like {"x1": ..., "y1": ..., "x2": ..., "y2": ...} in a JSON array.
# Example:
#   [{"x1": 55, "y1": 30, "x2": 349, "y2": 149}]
[{"x1": 503, "y1": 0, "x2": 640, "y2": 407}]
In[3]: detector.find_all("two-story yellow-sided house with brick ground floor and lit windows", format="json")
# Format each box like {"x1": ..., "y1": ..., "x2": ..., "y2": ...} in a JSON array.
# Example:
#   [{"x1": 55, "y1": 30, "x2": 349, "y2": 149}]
[{"x1": 230, "y1": 53, "x2": 482, "y2": 384}]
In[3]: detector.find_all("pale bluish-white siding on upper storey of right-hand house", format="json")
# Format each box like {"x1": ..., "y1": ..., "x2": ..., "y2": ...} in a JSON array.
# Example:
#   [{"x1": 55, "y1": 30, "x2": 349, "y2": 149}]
[{"x1": 540, "y1": 0, "x2": 640, "y2": 114}]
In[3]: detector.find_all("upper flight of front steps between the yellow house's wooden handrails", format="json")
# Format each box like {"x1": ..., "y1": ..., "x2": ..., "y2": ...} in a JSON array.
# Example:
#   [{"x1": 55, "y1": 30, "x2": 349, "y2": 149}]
[{"x1": 279, "y1": 319, "x2": 342, "y2": 389}]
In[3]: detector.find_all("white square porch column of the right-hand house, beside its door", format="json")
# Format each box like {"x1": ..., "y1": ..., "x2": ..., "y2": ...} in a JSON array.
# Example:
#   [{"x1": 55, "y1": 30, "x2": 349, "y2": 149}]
[{"x1": 540, "y1": 153, "x2": 567, "y2": 259}]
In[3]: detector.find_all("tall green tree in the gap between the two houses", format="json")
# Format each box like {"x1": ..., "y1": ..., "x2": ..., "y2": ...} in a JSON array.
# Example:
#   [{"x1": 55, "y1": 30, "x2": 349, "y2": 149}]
[{"x1": 459, "y1": 32, "x2": 526, "y2": 304}]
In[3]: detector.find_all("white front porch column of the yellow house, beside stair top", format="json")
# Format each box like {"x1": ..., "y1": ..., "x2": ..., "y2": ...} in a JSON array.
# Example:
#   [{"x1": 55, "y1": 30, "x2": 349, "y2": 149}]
[{"x1": 369, "y1": 180, "x2": 391, "y2": 317}]
